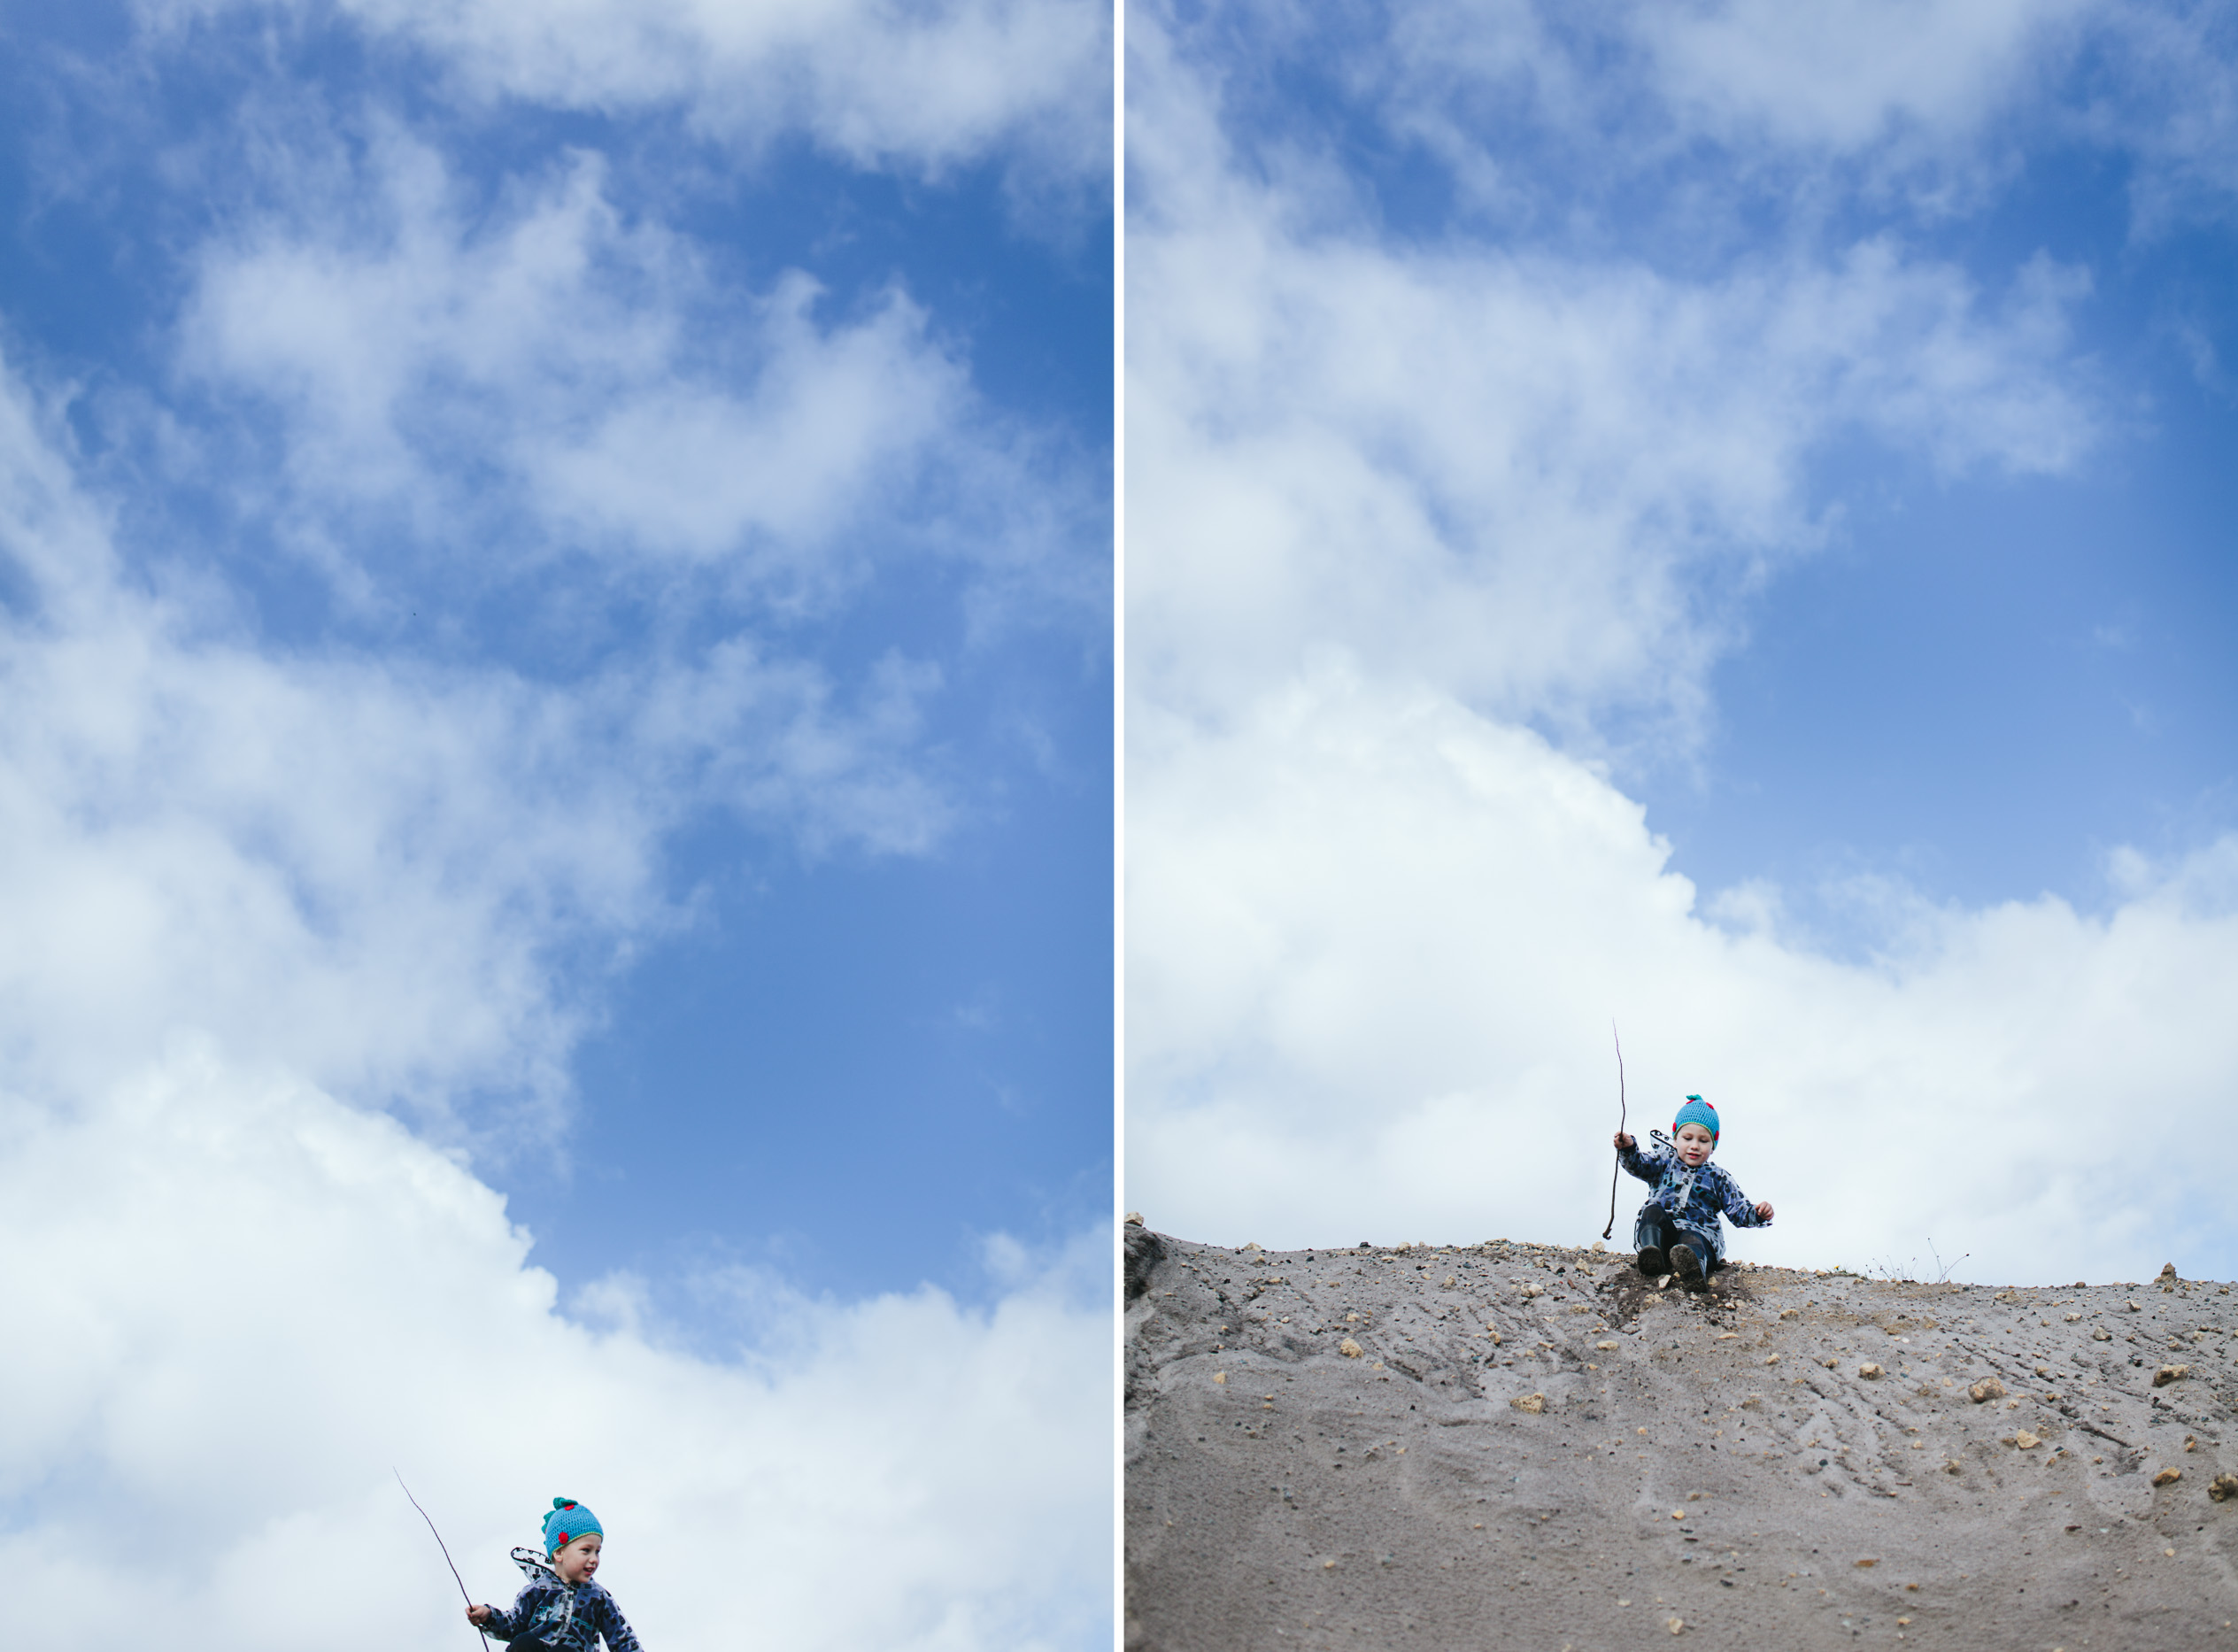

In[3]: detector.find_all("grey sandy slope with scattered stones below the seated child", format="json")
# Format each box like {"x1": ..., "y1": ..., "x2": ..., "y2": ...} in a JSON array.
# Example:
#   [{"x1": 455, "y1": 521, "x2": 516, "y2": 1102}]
[{"x1": 1126, "y1": 1227, "x2": 2238, "y2": 1652}]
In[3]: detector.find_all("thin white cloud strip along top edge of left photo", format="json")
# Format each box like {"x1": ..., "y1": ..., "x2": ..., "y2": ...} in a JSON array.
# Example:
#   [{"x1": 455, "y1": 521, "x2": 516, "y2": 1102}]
[{"x1": 139, "y1": 0, "x2": 1112, "y2": 183}]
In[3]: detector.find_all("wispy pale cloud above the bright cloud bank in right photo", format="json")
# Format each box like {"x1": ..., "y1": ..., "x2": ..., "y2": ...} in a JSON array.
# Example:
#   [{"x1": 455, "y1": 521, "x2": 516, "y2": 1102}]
[{"x1": 1128, "y1": 27, "x2": 2095, "y2": 743}]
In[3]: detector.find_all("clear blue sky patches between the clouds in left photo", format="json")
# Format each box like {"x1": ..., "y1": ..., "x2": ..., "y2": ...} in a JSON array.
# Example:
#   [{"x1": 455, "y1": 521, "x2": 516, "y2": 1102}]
[{"x1": 0, "y1": 0, "x2": 1112, "y2": 1292}]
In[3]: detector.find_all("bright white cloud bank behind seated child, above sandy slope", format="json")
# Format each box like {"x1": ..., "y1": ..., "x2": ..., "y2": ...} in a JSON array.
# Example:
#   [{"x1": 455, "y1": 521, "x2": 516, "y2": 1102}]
[{"x1": 1126, "y1": 672, "x2": 2238, "y2": 1283}]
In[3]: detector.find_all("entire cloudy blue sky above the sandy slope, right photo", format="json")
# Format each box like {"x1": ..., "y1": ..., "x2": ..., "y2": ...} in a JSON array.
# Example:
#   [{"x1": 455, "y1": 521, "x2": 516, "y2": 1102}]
[{"x1": 1126, "y1": 0, "x2": 2238, "y2": 1278}]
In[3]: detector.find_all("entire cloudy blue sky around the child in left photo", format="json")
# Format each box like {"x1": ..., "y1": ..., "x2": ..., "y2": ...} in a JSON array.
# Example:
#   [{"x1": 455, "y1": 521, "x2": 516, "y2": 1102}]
[{"x1": 0, "y1": 0, "x2": 1115, "y2": 1645}]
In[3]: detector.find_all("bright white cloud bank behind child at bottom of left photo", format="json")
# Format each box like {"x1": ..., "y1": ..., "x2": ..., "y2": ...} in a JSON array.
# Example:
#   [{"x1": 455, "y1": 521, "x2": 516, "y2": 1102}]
[{"x1": 0, "y1": 1038, "x2": 1112, "y2": 1652}]
